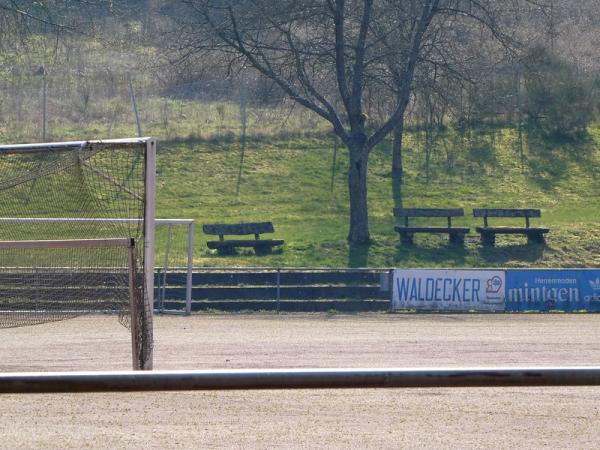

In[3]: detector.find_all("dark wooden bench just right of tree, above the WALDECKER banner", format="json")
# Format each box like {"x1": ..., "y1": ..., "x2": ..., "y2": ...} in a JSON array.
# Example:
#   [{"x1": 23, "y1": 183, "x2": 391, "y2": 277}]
[{"x1": 394, "y1": 208, "x2": 469, "y2": 244}]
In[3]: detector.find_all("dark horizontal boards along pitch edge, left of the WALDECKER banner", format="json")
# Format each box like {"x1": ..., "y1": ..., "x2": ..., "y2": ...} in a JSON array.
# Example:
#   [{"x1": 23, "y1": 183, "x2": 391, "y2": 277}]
[{"x1": 159, "y1": 267, "x2": 389, "y2": 312}]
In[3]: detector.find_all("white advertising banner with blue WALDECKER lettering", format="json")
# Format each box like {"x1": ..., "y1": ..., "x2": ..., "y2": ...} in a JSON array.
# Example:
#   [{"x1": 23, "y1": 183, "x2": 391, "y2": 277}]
[{"x1": 392, "y1": 269, "x2": 505, "y2": 311}]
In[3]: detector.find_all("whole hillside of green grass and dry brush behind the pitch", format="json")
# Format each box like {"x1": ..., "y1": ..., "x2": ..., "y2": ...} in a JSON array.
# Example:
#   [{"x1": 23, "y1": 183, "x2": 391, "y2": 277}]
[{"x1": 0, "y1": 0, "x2": 600, "y2": 267}]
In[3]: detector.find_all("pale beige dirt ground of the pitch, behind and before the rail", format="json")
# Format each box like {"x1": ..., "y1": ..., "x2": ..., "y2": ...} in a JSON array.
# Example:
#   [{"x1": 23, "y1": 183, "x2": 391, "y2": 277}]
[{"x1": 0, "y1": 314, "x2": 600, "y2": 449}]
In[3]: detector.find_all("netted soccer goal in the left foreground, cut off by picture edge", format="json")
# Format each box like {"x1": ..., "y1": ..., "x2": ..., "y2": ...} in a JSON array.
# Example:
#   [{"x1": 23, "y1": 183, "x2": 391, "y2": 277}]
[{"x1": 0, "y1": 138, "x2": 156, "y2": 369}]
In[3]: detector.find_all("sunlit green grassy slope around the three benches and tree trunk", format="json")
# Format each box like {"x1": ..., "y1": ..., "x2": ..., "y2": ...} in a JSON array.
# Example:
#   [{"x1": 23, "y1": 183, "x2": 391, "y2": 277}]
[{"x1": 158, "y1": 124, "x2": 600, "y2": 267}]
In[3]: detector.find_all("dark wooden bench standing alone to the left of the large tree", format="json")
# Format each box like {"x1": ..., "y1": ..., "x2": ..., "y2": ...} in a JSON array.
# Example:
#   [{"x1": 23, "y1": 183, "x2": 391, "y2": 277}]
[{"x1": 202, "y1": 222, "x2": 284, "y2": 253}]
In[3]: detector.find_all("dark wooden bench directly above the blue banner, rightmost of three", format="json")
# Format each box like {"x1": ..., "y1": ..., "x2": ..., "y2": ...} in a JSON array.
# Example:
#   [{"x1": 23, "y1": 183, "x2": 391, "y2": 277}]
[{"x1": 473, "y1": 208, "x2": 550, "y2": 246}]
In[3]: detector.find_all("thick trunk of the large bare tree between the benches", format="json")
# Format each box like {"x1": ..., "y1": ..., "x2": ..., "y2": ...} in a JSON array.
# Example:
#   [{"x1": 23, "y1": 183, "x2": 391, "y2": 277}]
[{"x1": 348, "y1": 140, "x2": 371, "y2": 244}]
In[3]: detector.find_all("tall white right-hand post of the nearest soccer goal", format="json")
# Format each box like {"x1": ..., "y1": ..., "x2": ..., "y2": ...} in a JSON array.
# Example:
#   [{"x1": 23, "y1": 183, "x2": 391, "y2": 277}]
[{"x1": 142, "y1": 139, "x2": 156, "y2": 370}]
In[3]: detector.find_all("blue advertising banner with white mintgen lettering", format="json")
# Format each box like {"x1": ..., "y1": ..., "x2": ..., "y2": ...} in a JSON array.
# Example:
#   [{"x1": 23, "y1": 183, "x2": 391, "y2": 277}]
[{"x1": 506, "y1": 269, "x2": 600, "y2": 311}]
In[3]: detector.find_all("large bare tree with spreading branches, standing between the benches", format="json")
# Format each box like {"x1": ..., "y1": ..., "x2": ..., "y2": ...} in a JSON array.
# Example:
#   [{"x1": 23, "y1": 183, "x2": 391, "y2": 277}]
[{"x1": 172, "y1": 0, "x2": 520, "y2": 244}]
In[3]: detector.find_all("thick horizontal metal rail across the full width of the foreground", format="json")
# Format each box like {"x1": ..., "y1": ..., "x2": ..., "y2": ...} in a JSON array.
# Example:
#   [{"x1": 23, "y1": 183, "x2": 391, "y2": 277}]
[{"x1": 0, "y1": 367, "x2": 600, "y2": 394}]
